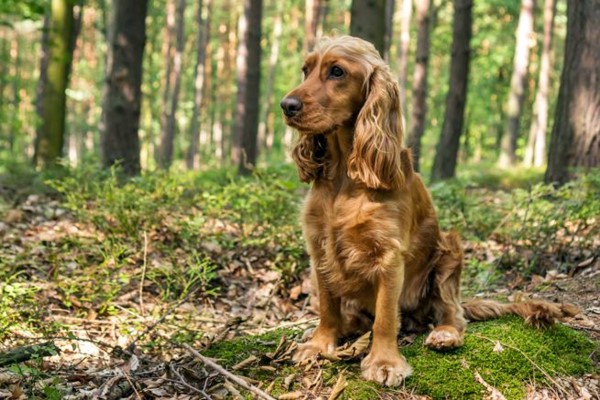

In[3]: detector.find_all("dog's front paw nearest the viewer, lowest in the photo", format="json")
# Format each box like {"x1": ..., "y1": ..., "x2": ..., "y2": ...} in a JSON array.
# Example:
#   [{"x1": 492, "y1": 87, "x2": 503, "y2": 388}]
[{"x1": 360, "y1": 353, "x2": 412, "y2": 386}]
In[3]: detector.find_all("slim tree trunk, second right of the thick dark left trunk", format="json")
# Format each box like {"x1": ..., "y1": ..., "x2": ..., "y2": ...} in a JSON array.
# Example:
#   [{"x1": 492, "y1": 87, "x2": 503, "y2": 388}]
[{"x1": 186, "y1": 0, "x2": 211, "y2": 169}]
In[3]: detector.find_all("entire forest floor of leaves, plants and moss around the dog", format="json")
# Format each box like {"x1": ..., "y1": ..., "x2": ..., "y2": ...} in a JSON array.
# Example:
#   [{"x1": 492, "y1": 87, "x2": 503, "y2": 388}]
[{"x1": 0, "y1": 164, "x2": 600, "y2": 399}]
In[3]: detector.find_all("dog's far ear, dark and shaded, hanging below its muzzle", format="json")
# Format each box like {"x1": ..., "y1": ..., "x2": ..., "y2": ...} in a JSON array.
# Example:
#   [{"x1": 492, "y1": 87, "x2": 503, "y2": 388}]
[{"x1": 292, "y1": 135, "x2": 327, "y2": 183}]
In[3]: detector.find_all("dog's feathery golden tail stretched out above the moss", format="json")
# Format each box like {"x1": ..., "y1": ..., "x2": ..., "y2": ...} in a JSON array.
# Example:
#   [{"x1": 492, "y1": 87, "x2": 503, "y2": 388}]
[{"x1": 462, "y1": 299, "x2": 579, "y2": 328}]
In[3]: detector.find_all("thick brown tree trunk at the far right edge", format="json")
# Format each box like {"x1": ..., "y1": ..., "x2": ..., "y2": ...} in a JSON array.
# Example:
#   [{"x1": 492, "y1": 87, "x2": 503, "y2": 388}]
[{"x1": 545, "y1": 0, "x2": 600, "y2": 184}]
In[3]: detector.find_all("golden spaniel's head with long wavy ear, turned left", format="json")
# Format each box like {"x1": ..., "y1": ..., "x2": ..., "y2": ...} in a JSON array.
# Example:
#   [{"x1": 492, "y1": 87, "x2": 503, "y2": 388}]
[{"x1": 281, "y1": 36, "x2": 404, "y2": 189}]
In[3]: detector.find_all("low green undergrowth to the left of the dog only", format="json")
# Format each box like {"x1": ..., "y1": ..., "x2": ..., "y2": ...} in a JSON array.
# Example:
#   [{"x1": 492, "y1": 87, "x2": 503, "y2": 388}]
[{"x1": 0, "y1": 165, "x2": 307, "y2": 340}]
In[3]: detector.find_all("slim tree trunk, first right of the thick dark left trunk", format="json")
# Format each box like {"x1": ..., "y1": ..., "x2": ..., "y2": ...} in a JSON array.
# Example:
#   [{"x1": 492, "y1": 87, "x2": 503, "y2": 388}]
[{"x1": 159, "y1": 0, "x2": 186, "y2": 169}]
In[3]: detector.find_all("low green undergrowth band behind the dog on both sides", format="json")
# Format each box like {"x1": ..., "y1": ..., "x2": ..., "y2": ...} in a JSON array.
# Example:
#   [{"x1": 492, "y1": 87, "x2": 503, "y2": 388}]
[{"x1": 0, "y1": 163, "x2": 600, "y2": 346}]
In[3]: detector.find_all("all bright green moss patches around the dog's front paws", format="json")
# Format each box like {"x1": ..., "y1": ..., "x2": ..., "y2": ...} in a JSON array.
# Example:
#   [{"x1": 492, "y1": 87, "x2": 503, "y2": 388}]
[{"x1": 205, "y1": 317, "x2": 598, "y2": 400}]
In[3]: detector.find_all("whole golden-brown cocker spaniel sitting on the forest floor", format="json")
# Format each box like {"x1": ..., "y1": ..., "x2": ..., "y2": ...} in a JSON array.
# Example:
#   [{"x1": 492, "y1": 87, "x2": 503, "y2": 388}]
[{"x1": 281, "y1": 36, "x2": 573, "y2": 385}]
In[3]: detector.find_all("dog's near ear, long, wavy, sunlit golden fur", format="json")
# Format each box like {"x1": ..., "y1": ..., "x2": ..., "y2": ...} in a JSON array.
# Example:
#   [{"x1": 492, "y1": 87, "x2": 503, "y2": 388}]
[{"x1": 348, "y1": 67, "x2": 404, "y2": 189}]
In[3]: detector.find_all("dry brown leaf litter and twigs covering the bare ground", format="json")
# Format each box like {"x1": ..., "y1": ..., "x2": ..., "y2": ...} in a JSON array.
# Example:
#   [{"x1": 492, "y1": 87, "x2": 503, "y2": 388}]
[{"x1": 0, "y1": 193, "x2": 600, "y2": 399}]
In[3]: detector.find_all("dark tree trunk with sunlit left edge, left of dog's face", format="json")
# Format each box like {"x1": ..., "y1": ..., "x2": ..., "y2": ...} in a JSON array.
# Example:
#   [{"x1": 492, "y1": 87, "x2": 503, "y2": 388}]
[{"x1": 233, "y1": 0, "x2": 262, "y2": 174}]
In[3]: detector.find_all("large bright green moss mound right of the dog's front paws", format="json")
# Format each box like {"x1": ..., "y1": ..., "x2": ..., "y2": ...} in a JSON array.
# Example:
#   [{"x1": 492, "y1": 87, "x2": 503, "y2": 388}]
[{"x1": 403, "y1": 317, "x2": 596, "y2": 398}]
